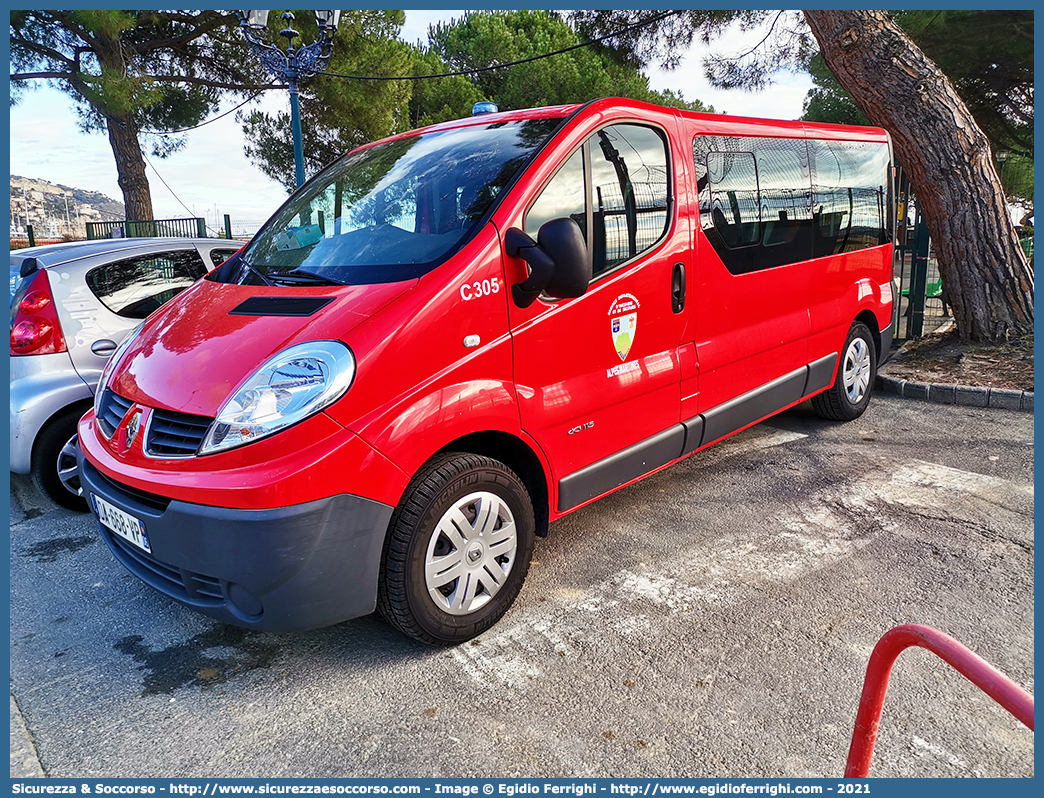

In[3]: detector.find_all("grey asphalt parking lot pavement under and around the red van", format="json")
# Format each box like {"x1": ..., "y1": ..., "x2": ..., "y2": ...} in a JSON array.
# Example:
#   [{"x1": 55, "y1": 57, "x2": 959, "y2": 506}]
[{"x1": 10, "y1": 395, "x2": 1034, "y2": 778}]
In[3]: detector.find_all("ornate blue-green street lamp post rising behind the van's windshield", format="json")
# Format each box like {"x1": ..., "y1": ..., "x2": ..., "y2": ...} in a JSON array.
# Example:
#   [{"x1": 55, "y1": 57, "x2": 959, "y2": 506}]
[{"x1": 236, "y1": 10, "x2": 340, "y2": 188}]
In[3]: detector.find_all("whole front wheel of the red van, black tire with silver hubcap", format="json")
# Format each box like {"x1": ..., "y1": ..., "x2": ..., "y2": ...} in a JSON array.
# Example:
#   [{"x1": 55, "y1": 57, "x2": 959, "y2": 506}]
[{"x1": 377, "y1": 452, "x2": 536, "y2": 646}]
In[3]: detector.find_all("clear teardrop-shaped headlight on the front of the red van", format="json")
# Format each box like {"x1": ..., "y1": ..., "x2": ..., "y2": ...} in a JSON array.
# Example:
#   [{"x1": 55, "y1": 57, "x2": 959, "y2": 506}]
[{"x1": 199, "y1": 341, "x2": 355, "y2": 454}]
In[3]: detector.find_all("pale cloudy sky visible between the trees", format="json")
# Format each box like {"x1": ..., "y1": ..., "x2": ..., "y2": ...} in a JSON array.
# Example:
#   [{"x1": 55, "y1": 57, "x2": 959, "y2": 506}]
[{"x1": 10, "y1": 10, "x2": 811, "y2": 228}]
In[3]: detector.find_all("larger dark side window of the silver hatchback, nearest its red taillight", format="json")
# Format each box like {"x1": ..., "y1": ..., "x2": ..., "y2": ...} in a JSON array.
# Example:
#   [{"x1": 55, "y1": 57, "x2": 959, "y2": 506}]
[{"x1": 87, "y1": 250, "x2": 208, "y2": 319}]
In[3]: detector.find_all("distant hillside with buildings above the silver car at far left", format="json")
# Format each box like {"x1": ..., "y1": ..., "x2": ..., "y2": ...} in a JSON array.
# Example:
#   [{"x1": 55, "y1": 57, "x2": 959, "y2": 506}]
[{"x1": 10, "y1": 174, "x2": 124, "y2": 239}]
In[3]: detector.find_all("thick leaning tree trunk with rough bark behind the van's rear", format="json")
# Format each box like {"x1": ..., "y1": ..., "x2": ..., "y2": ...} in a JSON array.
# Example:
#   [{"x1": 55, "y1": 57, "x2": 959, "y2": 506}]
[{"x1": 804, "y1": 10, "x2": 1034, "y2": 341}]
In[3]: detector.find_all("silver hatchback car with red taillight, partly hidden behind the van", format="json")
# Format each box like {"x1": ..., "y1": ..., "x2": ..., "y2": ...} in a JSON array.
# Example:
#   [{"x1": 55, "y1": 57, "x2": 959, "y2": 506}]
[{"x1": 10, "y1": 238, "x2": 241, "y2": 511}]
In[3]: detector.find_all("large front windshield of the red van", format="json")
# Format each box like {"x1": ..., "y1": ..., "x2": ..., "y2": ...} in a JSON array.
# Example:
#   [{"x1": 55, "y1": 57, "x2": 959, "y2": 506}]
[{"x1": 236, "y1": 118, "x2": 562, "y2": 285}]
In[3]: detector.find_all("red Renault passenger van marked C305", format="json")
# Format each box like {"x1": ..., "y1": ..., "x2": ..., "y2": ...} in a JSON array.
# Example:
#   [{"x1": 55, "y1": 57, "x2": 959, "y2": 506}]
[{"x1": 79, "y1": 99, "x2": 895, "y2": 643}]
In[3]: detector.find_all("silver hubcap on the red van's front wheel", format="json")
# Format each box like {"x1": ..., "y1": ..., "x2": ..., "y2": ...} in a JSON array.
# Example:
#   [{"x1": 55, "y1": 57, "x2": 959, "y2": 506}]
[{"x1": 424, "y1": 491, "x2": 518, "y2": 615}]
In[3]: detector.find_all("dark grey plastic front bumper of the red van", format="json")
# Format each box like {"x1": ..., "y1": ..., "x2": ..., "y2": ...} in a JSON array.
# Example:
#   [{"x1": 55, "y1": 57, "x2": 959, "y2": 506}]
[{"x1": 79, "y1": 454, "x2": 393, "y2": 632}]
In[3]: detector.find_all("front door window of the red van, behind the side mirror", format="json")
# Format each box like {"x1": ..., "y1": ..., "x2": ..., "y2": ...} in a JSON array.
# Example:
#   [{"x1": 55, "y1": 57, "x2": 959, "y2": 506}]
[{"x1": 523, "y1": 118, "x2": 669, "y2": 279}]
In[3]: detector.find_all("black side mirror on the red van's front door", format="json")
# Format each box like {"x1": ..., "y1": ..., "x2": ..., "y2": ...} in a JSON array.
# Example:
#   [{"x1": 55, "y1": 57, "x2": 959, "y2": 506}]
[{"x1": 504, "y1": 217, "x2": 591, "y2": 307}]
